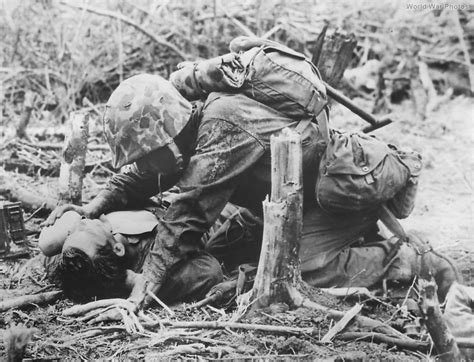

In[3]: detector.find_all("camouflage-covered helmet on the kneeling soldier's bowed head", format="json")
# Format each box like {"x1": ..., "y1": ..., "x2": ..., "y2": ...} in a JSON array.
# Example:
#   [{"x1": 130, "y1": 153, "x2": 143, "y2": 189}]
[{"x1": 103, "y1": 74, "x2": 192, "y2": 168}]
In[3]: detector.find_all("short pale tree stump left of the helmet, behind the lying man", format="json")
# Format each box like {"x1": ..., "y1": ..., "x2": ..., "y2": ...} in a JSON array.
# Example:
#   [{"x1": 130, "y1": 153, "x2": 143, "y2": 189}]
[{"x1": 59, "y1": 112, "x2": 89, "y2": 205}]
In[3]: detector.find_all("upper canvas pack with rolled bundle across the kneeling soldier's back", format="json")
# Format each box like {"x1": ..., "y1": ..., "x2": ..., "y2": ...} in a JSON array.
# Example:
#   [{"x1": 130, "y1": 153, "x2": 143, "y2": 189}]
[{"x1": 170, "y1": 37, "x2": 327, "y2": 119}]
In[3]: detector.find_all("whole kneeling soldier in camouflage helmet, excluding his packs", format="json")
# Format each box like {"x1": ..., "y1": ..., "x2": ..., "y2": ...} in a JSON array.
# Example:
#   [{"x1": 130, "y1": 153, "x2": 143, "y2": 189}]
[{"x1": 47, "y1": 74, "x2": 455, "y2": 312}]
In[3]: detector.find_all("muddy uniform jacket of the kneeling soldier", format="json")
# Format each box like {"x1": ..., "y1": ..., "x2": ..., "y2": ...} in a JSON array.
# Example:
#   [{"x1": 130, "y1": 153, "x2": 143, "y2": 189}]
[{"x1": 99, "y1": 93, "x2": 320, "y2": 294}]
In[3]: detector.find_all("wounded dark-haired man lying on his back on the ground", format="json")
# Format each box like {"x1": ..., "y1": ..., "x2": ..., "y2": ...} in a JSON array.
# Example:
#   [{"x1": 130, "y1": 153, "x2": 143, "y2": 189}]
[{"x1": 39, "y1": 199, "x2": 262, "y2": 303}]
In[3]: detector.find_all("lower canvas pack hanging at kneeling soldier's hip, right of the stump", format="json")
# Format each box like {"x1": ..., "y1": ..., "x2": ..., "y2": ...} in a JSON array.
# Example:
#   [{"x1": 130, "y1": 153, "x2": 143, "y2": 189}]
[{"x1": 315, "y1": 112, "x2": 422, "y2": 219}]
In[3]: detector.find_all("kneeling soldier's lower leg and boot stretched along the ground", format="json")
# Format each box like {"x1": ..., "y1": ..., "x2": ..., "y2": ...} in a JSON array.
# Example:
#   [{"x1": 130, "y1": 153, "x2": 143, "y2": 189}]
[{"x1": 303, "y1": 223, "x2": 460, "y2": 301}]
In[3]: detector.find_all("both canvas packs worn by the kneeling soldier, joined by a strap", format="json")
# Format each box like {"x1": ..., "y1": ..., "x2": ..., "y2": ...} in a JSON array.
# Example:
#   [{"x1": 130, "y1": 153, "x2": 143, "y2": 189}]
[{"x1": 170, "y1": 37, "x2": 422, "y2": 218}]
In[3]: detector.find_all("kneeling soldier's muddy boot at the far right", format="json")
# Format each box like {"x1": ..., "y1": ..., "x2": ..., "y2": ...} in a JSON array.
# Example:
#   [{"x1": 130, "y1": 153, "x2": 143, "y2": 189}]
[{"x1": 387, "y1": 233, "x2": 460, "y2": 303}]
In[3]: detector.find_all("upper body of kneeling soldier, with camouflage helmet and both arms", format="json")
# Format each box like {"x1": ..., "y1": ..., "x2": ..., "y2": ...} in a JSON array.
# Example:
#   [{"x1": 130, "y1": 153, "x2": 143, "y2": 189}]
[{"x1": 46, "y1": 74, "x2": 326, "y2": 304}]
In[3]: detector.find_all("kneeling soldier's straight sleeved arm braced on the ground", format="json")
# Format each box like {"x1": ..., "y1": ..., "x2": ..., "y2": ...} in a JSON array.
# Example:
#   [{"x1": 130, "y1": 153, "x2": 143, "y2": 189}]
[{"x1": 136, "y1": 119, "x2": 265, "y2": 305}]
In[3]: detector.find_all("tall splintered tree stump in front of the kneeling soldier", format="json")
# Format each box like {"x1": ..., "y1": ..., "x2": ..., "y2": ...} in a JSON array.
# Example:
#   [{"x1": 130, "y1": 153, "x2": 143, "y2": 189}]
[{"x1": 244, "y1": 129, "x2": 303, "y2": 309}]
